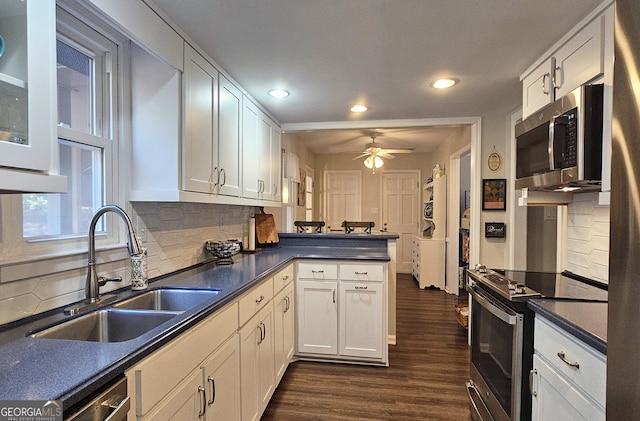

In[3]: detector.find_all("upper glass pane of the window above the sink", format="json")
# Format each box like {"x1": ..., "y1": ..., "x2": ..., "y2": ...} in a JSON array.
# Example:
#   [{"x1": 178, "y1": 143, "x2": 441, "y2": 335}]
[{"x1": 57, "y1": 40, "x2": 95, "y2": 134}]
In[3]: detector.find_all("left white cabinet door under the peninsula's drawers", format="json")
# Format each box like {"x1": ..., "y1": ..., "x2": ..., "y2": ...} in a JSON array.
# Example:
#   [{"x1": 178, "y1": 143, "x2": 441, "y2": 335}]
[{"x1": 296, "y1": 280, "x2": 338, "y2": 355}]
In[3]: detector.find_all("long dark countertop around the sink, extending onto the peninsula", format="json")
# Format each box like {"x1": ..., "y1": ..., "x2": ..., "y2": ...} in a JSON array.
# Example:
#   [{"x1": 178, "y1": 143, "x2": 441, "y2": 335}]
[{"x1": 0, "y1": 234, "x2": 397, "y2": 410}]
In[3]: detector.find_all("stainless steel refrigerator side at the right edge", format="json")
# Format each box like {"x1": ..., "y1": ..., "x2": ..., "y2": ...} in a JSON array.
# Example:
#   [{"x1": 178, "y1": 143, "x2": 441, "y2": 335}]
[{"x1": 607, "y1": 0, "x2": 640, "y2": 420}]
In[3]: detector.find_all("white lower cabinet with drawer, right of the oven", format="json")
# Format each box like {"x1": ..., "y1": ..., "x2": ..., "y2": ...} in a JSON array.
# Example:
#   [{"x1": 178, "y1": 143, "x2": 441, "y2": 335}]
[{"x1": 529, "y1": 315, "x2": 606, "y2": 421}]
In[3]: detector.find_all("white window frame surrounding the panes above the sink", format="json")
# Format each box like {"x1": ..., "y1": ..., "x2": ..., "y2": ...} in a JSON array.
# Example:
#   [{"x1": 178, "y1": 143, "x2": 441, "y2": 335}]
[{"x1": 0, "y1": 2, "x2": 130, "y2": 264}]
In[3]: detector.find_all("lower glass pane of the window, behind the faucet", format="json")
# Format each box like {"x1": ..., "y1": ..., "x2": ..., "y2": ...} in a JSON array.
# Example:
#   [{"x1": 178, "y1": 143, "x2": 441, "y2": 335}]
[{"x1": 22, "y1": 140, "x2": 104, "y2": 238}]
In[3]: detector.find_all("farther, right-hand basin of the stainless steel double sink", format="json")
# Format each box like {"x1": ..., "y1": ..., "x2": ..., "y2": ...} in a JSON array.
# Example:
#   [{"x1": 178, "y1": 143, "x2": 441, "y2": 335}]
[{"x1": 113, "y1": 288, "x2": 220, "y2": 311}]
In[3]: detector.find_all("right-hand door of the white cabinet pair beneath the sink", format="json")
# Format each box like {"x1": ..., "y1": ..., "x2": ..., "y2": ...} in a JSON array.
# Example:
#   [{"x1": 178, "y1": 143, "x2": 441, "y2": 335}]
[{"x1": 202, "y1": 335, "x2": 240, "y2": 421}]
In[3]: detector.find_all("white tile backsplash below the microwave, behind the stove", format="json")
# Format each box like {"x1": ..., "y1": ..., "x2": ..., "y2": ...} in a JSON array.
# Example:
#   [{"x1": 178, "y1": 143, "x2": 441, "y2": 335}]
[{"x1": 567, "y1": 193, "x2": 609, "y2": 282}]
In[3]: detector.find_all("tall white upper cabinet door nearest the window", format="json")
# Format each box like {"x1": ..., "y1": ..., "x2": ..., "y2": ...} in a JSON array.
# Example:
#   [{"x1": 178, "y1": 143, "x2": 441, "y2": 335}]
[{"x1": 183, "y1": 44, "x2": 218, "y2": 193}]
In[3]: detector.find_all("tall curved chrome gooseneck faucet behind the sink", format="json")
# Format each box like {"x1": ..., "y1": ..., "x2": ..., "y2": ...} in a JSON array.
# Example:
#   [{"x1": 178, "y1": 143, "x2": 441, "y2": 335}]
[{"x1": 64, "y1": 205, "x2": 143, "y2": 314}]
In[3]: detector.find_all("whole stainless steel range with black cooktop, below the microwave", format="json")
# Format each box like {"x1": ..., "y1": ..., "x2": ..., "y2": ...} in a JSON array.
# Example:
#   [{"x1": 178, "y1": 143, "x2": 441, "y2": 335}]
[{"x1": 467, "y1": 270, "x2": 607, "y2": 421}]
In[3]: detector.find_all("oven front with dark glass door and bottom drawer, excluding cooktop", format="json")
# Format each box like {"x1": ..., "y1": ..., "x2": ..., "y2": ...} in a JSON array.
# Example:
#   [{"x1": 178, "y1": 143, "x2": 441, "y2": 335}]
[{"x1": 467, "y1": 278, "x2": 524, "y2": 420}]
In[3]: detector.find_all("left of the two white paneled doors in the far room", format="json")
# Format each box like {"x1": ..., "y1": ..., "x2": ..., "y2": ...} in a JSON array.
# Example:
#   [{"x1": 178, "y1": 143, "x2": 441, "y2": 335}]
[{"x1": 324, "y1": 171, "x2": 362, "y2": 230}]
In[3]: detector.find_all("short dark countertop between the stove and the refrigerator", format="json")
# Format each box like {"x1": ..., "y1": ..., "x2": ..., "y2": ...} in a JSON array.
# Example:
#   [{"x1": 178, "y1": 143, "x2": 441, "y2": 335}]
[{"x1": 529, "y1": 299, "x2": 608, "y2": 355}]
